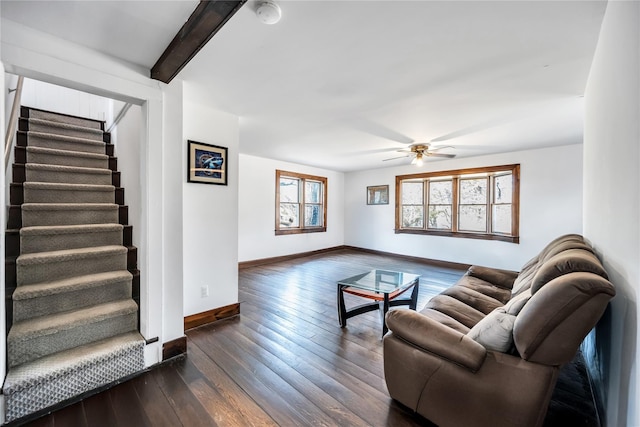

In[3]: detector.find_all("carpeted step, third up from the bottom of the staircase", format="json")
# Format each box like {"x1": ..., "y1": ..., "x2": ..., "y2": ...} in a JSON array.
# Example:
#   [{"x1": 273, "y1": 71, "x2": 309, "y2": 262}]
[{"x1": 12, "y1": 270, "x2": 133, "y2": 322}]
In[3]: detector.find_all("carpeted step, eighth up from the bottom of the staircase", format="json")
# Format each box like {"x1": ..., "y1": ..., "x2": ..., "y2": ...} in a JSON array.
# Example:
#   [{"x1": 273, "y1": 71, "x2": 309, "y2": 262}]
[{"x1": 25, "y1": 163, "x2": 112, "y2": 185}]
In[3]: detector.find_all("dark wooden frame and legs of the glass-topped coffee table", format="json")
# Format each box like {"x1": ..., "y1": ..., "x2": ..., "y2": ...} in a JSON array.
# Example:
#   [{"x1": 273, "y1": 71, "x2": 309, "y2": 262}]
[{"x1": 338, "y1": 276, "x2": 420, "y2": 337}]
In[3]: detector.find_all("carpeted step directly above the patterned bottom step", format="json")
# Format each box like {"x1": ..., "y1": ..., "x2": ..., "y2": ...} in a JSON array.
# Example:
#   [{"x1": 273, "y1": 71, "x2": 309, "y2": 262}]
[{"x1": 7, "y1": 299, "x2": 138, "y2": 368}]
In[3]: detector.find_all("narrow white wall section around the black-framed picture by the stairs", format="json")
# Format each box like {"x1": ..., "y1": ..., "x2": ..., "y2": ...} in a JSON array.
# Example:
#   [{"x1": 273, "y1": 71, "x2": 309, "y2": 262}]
[{"x1": 182, "y1": 89, "x2": 239, "y2": 316}]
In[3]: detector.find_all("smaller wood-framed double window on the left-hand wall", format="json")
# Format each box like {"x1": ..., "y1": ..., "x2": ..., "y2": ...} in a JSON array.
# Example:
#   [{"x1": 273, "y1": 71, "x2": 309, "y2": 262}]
[{"x1": 276, "y1": 170, "x2": 327, "y2": 235}]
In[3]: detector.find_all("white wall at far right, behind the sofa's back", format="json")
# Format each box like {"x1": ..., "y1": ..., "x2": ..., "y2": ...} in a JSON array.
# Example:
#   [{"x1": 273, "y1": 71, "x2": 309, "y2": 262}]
[{"x1": 584, "y1": 1, "x2": 640, "y2": 427}]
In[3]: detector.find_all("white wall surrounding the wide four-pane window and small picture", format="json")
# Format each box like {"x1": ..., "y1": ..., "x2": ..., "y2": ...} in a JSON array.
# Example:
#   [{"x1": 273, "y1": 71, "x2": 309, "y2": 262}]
[{"x1": 345, "y1": 145, "x2": 582, "y2": 270}]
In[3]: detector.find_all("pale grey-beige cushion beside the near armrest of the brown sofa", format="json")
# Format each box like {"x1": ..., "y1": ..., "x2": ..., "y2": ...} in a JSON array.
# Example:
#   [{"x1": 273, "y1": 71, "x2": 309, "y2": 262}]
[{"x1": 467, "y1": 307, "x2": 516, "y2": 353}]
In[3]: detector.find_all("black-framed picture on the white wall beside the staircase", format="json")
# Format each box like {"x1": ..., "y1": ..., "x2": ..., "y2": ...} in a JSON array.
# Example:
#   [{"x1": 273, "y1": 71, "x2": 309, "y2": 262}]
[{"x1": 187, "y1": 140, "x2": 229, "y2": 185}]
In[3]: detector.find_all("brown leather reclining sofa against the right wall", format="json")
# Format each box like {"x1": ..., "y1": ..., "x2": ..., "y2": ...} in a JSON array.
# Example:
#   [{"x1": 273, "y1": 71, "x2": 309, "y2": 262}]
[{"x1": 383, "y1": 235, "x2": 615, "y2": 427}]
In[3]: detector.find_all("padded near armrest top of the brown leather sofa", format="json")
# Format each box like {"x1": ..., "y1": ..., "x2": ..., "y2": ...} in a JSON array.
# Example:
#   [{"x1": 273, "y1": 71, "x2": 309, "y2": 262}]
[{"x1": 386, "y1": 310, "x2": 487, "y2": 372}]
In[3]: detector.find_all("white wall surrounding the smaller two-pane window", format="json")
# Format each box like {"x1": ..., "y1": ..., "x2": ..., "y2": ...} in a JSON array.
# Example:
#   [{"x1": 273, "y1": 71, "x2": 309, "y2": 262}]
[{"x1": 238, "y1": 154, "x2": 344, "y2": 262}]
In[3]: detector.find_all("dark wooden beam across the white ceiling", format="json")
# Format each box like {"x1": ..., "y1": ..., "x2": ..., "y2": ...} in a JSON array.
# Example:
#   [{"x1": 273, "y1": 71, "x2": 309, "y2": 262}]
[{"x1": 151, "y1": 0, "x2": 247, "y2": 83}]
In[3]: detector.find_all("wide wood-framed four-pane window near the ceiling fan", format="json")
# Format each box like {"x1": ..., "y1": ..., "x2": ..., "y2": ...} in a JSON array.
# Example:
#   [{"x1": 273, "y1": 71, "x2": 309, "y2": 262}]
[{"x1": 396, "y1": 165, "x2": 520, "y2": 243}]
